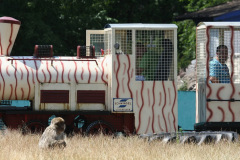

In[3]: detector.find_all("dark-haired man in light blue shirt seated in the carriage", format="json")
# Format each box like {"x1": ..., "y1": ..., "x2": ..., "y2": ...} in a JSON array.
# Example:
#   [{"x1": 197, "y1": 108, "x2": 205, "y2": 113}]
[{"x1": 209, "y1": 45, "x2": 230, "y2": 83}]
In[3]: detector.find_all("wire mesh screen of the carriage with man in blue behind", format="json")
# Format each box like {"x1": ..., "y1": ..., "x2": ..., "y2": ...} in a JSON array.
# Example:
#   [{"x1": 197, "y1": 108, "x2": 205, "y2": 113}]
[{"x1": 196, "y1": 28, "x2": 240, "y2": 83}]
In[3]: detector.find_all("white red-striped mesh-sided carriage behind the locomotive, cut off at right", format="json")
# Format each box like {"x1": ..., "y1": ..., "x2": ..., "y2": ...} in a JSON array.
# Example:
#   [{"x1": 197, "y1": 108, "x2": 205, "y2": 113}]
[{"x1": 195, "y1": 22, "x2": 240, "y2": 132}]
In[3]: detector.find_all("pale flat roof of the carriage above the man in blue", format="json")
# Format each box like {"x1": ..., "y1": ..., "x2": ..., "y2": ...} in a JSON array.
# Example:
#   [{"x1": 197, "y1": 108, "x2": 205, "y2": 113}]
[{"x1": 197, "y1": 22, "x2": 240, "y2": 28}]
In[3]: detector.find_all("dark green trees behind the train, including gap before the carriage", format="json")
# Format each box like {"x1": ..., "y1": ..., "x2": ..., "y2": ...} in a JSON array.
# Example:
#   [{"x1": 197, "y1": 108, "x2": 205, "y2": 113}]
[{"x1": 0, "y1": 0, "x2": 233, "y2": 69}]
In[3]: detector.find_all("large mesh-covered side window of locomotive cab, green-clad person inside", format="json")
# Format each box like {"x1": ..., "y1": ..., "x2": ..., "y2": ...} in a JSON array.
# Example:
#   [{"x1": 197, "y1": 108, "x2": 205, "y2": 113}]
[{"x1": 135, "y1": 30, "x2": 174, "y2": 81}]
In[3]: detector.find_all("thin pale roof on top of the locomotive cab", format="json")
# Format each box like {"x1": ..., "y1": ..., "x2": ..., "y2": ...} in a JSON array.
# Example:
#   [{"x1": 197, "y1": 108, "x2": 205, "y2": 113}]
[{"x1": 104, "y1": 23, "x2": 178, "y2": 29}]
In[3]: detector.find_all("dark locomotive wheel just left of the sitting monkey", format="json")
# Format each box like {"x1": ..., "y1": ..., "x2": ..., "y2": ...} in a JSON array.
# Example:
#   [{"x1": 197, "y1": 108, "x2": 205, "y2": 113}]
[{"x1": 22, "y1": 120, "x2": 47, "y2": 134}]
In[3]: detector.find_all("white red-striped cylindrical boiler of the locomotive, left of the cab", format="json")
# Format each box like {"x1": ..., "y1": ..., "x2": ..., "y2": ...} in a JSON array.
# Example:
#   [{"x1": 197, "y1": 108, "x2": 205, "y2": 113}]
[{"x1": 0, "y1": 56, "x2": 109, "y2": 110}]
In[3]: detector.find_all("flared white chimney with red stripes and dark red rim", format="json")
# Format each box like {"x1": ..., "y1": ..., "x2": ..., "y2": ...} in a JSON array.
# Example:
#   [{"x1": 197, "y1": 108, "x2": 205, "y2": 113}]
[{"x1": 0, "y1": 17, "x2": 21, "y2": 56}]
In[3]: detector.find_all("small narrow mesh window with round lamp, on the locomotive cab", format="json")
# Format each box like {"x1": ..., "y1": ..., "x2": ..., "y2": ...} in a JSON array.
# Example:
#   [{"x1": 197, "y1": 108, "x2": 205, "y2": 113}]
[{"x1": 114, "y1": 30, "x2": 132, "y2": 54}]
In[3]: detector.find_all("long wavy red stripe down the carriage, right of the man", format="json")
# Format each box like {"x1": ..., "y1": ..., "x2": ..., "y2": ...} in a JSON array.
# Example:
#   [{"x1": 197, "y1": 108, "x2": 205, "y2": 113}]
[{"x1": 228, "y1": 26, "x2": 235, "y2": 122}]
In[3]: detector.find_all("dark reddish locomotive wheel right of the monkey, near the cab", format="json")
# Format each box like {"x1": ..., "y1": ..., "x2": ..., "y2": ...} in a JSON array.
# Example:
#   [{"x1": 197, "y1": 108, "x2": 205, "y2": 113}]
[{"x1": 86, "y1": 120, "x2": 114, "y2": 135}]
